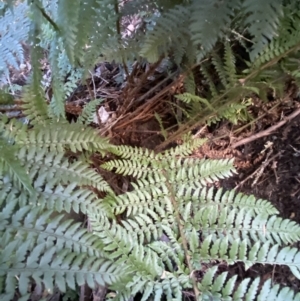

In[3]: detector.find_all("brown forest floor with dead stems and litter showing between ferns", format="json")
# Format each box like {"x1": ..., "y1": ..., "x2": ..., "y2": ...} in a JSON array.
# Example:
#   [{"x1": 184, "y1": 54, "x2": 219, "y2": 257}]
[{"x1": 4, "y1": 58, "x2": 300, "y2": 291}]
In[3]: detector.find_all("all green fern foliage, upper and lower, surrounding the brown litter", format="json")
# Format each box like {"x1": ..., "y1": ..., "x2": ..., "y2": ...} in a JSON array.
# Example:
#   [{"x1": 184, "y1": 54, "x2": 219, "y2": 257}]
[{"x1": 0, "y1": 0, "x2": 300, "y2": 301}]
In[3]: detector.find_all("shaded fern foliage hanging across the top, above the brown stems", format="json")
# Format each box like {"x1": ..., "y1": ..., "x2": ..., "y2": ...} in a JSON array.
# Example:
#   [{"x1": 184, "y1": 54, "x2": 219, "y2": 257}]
[{"x1": 0, "y1": 0, "x2": 300, "y2": 123}]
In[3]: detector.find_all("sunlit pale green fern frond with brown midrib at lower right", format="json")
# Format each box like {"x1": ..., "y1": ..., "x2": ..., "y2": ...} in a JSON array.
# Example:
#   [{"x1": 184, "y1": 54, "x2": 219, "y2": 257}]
[{"x1": 99, "y1": 143, "x2": 300, "y2": 300}]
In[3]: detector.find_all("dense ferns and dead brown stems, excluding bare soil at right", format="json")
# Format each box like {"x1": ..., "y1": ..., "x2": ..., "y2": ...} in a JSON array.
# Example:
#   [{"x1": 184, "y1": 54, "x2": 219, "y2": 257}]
[{"x1": 0, "y1": 0, "x2": 300, "y2": 301}]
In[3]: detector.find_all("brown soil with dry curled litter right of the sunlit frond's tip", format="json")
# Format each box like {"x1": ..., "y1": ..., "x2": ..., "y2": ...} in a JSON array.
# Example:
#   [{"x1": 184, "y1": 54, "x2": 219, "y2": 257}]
[{"x1": 192, "y1": 100, "x2": 300, "y2": 291}]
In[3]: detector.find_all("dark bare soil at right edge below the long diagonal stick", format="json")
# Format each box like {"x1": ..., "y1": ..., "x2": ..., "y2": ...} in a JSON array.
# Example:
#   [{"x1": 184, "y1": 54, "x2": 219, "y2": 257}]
[{"x1": 223, "y1": 112, "x2": 300, "y2": 291}]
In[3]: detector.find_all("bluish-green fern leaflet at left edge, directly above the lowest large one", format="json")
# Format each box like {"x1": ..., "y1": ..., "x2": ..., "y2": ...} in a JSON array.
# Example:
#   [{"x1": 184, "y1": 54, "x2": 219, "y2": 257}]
[{"x1": 0, "y1": 205, "x2": 103, "y2": 258}]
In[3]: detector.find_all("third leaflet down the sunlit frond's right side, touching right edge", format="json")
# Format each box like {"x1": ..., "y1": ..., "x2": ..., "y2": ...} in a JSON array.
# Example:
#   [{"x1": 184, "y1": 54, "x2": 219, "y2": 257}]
[{"x1": 197, "y1": 206, "x2": 300, "y2": 245}]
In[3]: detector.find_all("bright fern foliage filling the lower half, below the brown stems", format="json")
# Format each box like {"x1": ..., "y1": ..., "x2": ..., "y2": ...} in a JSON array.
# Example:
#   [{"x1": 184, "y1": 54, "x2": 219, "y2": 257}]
[{"x1": 0, "y1": 105, "x2": 300, "y2": 300}]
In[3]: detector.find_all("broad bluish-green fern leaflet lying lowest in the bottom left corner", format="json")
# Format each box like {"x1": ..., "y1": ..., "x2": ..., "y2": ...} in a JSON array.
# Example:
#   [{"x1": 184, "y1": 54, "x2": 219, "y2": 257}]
[{"x1": 0, "y1": 240, "x2": 125, "y2": 300}]
